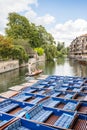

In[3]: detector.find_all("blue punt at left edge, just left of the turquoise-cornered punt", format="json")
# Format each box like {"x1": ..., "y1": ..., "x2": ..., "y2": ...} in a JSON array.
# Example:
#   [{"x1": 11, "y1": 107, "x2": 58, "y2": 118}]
[{"x1": 0, "y1": 99, "x2": 34, "y2": 117}]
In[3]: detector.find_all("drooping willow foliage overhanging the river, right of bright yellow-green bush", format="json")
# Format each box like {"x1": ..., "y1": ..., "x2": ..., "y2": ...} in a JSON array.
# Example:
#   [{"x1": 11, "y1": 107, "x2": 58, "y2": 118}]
[{"x1": 43, "y1": 44, "x2": 57, "y2": 60}]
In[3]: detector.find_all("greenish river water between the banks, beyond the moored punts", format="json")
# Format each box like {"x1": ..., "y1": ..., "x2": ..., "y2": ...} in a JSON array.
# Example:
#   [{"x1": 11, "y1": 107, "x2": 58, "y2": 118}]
[{"x1": 0, "y1": 58, "x2": 87, "y2": 93}]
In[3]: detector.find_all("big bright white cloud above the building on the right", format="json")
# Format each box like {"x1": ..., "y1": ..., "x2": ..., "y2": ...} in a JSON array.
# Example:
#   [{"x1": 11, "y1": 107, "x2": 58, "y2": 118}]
[{"x1": 50, "y1": 19, "x2": 87, "y2": 46}]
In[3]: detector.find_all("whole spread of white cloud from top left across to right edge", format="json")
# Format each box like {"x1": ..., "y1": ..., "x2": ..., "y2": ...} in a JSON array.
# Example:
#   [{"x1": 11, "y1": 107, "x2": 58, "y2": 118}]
[{"x1": 0, "y1": 0, "x2": 87, "y2": 45}]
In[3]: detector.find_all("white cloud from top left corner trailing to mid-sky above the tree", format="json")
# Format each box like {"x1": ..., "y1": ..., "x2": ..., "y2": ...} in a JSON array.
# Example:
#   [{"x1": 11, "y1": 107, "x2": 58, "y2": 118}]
[{"x1": 0, "y1": 0, "x2": 55, "y2": 34}]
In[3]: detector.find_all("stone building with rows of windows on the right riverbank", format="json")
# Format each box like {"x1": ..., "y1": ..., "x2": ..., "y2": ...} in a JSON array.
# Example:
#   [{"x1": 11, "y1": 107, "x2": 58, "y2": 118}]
[{"x1": 69, "y1": 34, "x2": 87, "y2": 61}]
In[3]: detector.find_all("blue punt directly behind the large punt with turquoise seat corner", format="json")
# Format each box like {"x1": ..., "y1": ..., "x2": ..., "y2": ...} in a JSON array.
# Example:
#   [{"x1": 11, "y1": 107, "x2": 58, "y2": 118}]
[{"x1": 41, "y1": 97, "x2": 80, "y2": 111}]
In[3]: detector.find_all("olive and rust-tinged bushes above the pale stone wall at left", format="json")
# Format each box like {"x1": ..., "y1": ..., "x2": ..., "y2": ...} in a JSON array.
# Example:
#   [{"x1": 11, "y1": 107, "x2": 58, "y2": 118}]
[{"x1": 0, "y1": 36, "x2": 28, "y2": 64}]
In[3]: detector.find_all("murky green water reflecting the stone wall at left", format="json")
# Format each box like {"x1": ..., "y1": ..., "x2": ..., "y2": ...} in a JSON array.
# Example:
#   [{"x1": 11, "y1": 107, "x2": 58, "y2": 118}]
[{"x1": 0, "y1": 68, "x2": 27, "y2": 92}]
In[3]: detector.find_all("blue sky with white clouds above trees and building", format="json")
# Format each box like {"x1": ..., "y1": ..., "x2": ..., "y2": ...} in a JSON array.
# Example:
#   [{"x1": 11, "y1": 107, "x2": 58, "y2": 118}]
[{"x1": 0, "y1": 0, "x2": 87, "y2": 46}]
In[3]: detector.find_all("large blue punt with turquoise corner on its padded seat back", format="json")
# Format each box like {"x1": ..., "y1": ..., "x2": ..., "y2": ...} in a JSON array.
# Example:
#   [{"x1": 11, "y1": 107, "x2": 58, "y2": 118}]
[{"x1": 25, "y1": 105, "x2": 76, "y2": 129}]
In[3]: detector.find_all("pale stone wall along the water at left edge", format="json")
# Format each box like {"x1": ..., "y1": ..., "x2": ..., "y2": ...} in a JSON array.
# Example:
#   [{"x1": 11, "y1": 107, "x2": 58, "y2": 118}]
[{"x1": 0, "y1": 60, "x2": 19, "y2": 73}]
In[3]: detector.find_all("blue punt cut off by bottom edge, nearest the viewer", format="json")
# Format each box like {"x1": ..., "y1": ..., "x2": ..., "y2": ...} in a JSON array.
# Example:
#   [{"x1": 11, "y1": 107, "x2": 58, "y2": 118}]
[{"x1": 4, "y1": 119, "x2": 61, "y2": 130}]
